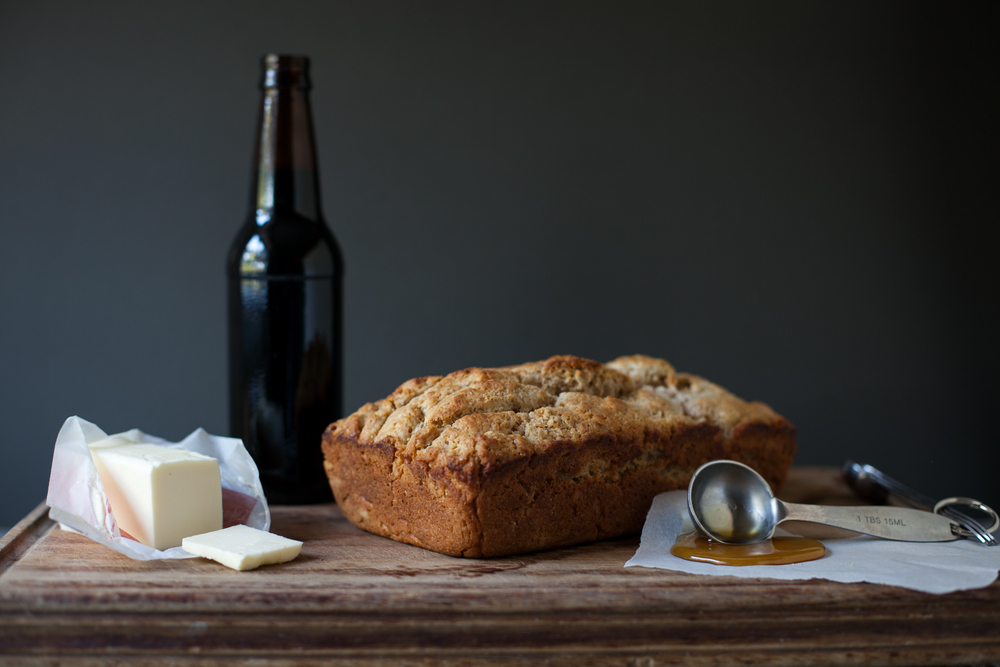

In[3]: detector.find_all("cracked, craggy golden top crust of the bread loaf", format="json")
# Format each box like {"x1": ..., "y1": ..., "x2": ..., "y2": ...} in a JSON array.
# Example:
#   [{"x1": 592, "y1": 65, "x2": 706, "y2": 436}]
[{"x1": 328, "y1": 355, "x2": 792, "y2": 476}]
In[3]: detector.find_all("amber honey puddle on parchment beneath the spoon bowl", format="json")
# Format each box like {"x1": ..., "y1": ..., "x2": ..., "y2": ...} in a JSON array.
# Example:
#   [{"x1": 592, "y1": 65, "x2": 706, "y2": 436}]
[{"x1": 670, "y1": 532, "x2": 826, "y2": 565}]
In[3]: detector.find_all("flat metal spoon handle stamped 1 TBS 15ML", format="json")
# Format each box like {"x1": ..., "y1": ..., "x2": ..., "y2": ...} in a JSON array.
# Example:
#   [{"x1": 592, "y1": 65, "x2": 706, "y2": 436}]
[{"x1": 779, "y1": 502, "x2": 958, "y2": 542}]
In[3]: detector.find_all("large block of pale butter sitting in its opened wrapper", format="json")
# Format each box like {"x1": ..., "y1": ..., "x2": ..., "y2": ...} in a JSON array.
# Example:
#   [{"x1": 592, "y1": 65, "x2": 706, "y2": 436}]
[{"x1": 90, "y1": 438, "x2": 222, "y2": 550}]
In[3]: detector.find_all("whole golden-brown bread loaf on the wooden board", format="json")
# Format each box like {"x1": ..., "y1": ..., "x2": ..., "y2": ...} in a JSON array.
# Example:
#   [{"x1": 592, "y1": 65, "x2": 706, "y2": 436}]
[{"x1": 323, "y1": 356, "x2": 795, "y2": 557}]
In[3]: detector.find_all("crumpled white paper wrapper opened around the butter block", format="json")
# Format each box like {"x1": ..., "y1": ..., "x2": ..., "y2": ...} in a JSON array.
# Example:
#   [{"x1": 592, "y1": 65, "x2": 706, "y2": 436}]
[{"x1": 45, "y1": 417, "x2": 271, "y2": 560}]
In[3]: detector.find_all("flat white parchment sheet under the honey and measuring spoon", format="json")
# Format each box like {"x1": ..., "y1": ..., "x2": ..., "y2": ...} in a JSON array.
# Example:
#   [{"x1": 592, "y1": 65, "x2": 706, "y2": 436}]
[{"x1": 625, "y1": 491, "x2": 1000, "y2": 593}]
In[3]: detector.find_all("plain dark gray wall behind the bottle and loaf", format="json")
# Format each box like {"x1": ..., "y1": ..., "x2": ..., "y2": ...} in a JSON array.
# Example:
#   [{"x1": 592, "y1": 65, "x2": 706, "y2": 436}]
[{"x1": 0, "y1": 1, "x2": 1000, "y2": 526}]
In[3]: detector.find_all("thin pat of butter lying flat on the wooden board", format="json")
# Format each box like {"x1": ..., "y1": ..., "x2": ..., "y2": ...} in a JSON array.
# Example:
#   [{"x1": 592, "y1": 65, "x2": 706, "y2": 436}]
[{"x1": 182, "y1": 526, "x2": 302, "y2": 570}]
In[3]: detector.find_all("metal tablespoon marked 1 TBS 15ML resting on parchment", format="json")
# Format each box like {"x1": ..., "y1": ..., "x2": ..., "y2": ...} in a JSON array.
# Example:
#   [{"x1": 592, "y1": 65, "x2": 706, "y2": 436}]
[{"x1": 688, "y1": 460, "x2": 958, "y2": 544}]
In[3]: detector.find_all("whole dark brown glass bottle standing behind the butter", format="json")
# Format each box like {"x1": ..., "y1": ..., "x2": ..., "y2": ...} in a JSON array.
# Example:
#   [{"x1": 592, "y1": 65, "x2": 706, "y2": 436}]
[{"x1": 227, "y1": 54, "x2": 343, "y2": 504}]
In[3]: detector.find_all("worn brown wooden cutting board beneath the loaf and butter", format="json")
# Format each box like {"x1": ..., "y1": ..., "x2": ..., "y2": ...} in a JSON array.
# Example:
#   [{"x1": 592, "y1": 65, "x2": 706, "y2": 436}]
[{"x1": 0, "y1": 468, "x2": 1000, "y2": 667}]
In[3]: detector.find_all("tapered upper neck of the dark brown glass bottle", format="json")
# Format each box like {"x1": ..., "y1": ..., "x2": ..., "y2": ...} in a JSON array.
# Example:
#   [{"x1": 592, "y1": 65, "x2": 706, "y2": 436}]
[{"x1": 250, "y1": 56, "x2": 322, "y2": 225}]
